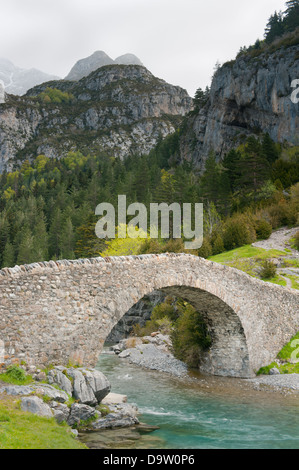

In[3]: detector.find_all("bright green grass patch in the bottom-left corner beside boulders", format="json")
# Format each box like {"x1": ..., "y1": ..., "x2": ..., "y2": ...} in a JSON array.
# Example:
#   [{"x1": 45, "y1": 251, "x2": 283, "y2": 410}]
[{"x1": 0, "y1": 398, "x2": 86, "y2": 449}]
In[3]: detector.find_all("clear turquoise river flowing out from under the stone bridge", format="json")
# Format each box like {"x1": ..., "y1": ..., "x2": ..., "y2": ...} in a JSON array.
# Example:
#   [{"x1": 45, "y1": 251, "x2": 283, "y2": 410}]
[{"x1": 81, "y1": 351, "x2": 299, "y2": 449}]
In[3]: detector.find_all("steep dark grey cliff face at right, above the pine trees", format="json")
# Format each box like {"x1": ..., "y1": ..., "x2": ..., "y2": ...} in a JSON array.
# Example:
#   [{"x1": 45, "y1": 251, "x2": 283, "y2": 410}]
[{"x1": 180, "y1": 45, "x2": 299, "y2": 169}]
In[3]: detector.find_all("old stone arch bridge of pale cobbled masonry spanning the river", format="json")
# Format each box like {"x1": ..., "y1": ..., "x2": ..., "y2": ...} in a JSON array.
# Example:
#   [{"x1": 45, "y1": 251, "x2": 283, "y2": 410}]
[{"x1": 0, "y1": 254, "x2": 299, "y2": 377}]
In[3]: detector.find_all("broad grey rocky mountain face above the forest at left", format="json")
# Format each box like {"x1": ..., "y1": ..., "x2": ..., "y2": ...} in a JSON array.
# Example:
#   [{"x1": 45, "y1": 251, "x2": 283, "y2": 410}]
[{"x1": 0, "y1": 65, "x2": 193, "y2": 171}]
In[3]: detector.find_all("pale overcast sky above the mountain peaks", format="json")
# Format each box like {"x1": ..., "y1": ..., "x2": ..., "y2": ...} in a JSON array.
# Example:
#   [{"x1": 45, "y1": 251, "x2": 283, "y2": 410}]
[{"x1": 0, "y1": 0, "x2": 285, "y2": 96}]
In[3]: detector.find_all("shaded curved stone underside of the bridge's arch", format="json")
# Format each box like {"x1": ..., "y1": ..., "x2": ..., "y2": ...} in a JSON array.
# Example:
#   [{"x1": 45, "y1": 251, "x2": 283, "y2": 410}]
[{"x1": 107, "y1": 285, "x2": 254, "y2": 378}]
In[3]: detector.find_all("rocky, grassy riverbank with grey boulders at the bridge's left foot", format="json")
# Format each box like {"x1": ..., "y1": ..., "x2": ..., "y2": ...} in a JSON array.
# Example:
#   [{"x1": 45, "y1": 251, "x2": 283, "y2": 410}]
[{"x1": 0, "y1": 366, "x2": 156, "y2": 449}]
